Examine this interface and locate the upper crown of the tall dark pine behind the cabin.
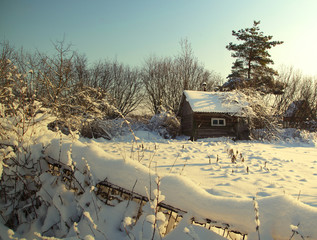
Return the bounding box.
[226,21,283,80]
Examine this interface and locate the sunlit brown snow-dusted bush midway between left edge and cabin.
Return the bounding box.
[48,86,119,138]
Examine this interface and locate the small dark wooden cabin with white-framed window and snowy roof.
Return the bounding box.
[178,90,250,140]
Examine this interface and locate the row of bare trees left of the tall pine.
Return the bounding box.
[0,37,222,118]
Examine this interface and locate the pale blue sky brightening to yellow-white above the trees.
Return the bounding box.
[0,0,317,77]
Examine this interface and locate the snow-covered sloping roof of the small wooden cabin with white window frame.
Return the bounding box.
[184,90,248,115]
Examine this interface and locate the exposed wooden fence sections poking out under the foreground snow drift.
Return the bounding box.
[45,157,247,240]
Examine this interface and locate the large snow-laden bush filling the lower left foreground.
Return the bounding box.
[0,62,104,239]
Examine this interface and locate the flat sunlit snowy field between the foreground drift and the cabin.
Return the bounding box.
[91,131,317,208]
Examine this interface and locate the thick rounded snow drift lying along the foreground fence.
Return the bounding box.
[47,132,317,239]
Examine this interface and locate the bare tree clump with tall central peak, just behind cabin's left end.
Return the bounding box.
[142,40,222,113]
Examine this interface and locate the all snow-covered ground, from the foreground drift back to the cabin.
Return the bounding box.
[0,115,317,240]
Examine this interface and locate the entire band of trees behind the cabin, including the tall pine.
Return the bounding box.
[0,21,317,132]
